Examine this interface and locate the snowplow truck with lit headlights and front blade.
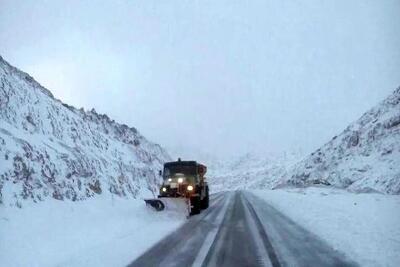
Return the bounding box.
[145,159,209,215]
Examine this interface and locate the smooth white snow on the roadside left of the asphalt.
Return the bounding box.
[0,194,185,267]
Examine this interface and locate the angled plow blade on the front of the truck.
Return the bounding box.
[144,197,190,215]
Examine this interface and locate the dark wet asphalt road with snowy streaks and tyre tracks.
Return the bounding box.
[129,191,357,267]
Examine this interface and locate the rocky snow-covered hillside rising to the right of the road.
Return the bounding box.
[281,88,400,194]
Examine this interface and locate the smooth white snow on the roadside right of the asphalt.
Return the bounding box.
[252,187,400,267]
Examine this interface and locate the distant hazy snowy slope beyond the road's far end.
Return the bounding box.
[207,152,300,192]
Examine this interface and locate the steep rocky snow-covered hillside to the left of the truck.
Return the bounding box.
[0,57,170,206]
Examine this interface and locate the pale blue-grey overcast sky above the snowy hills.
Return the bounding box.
[0,0,400,158]
